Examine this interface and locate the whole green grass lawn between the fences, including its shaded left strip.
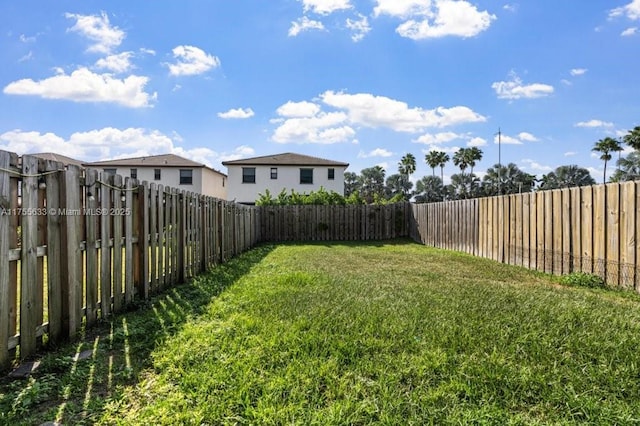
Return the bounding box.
[0,241,640,425]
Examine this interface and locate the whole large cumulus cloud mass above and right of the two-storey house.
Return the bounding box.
[271,90,486,143]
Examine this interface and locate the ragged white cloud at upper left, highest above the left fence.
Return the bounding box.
[65,12,126,54]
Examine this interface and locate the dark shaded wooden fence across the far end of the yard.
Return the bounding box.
[260,203,411,242]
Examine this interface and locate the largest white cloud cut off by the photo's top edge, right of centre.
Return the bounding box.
[374,0,496,40]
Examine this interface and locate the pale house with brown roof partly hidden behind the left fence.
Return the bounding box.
[83,154,227,200]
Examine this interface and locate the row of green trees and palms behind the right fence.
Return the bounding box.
[345,126,640,203]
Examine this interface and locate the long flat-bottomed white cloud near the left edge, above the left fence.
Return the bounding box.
[3,68,156,108]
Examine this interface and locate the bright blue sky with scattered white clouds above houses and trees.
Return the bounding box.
[0,0,640,185]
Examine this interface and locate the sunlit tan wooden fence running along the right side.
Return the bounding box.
[411,182,640,291]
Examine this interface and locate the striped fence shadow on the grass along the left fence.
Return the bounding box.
[0,245,273,424]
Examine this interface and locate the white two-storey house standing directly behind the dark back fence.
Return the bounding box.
[222,153,349,204]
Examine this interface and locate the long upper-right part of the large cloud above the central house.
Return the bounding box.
[320,90,486,133]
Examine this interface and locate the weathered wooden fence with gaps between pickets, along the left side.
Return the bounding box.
[0,151,260,368]
